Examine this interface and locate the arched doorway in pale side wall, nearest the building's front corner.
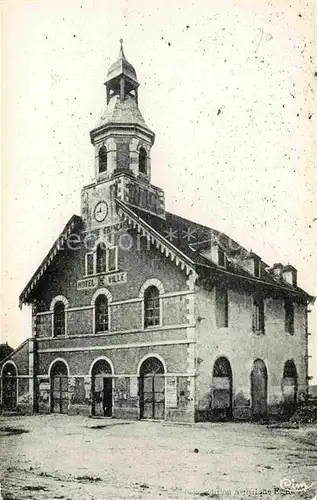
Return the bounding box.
[211,357,232,420]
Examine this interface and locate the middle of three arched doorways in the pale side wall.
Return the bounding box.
[251,359,267,418]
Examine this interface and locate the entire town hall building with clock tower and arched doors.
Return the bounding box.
[0,45,313,421]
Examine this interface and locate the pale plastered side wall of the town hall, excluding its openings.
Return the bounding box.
[196,287,308,420]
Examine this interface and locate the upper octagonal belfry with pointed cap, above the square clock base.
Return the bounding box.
[90,39,155,182]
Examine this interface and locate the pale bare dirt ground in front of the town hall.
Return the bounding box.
[0,415,317,500]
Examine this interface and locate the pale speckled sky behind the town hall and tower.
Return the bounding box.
[1,0,317,383]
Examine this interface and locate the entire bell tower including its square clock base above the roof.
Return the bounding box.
[82,39,165,229]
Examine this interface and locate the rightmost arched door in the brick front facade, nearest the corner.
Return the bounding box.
[140,357,165,420]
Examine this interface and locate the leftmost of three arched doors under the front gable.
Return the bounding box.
[50,361,68,413]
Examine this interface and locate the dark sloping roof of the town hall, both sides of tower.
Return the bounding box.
[19,200,314,306]
